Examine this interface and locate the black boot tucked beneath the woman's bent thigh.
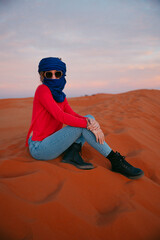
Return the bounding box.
[62,143,94,169]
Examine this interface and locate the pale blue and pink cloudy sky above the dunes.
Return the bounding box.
[0,0,160,98]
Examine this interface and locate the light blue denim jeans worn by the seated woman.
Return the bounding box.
[28,114,112,160]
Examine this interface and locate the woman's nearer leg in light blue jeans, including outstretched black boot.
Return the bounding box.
[29,115,144,179]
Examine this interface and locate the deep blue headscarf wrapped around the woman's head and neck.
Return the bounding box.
[38,57,66,102]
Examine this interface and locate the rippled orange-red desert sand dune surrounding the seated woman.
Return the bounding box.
[0,90,160,240]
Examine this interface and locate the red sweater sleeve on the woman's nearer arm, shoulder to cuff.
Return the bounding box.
[37,85,87,128]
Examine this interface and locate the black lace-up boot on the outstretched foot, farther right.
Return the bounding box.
[106,151,144,179]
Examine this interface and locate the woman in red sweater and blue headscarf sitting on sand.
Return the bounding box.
[26,57,144,179]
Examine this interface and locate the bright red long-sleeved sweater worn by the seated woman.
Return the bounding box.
[26,84,87,146]
